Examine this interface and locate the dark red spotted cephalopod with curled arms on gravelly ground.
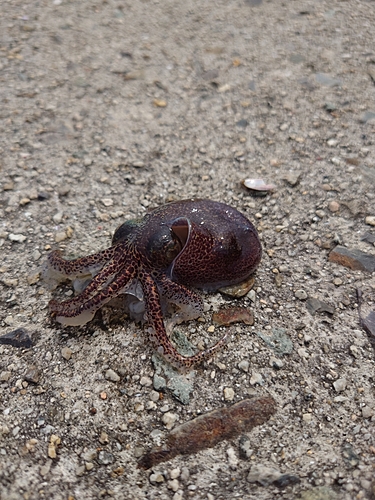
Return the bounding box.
[45,199,261,368]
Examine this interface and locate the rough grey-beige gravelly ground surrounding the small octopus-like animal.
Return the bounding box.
[0,0,375,500]
